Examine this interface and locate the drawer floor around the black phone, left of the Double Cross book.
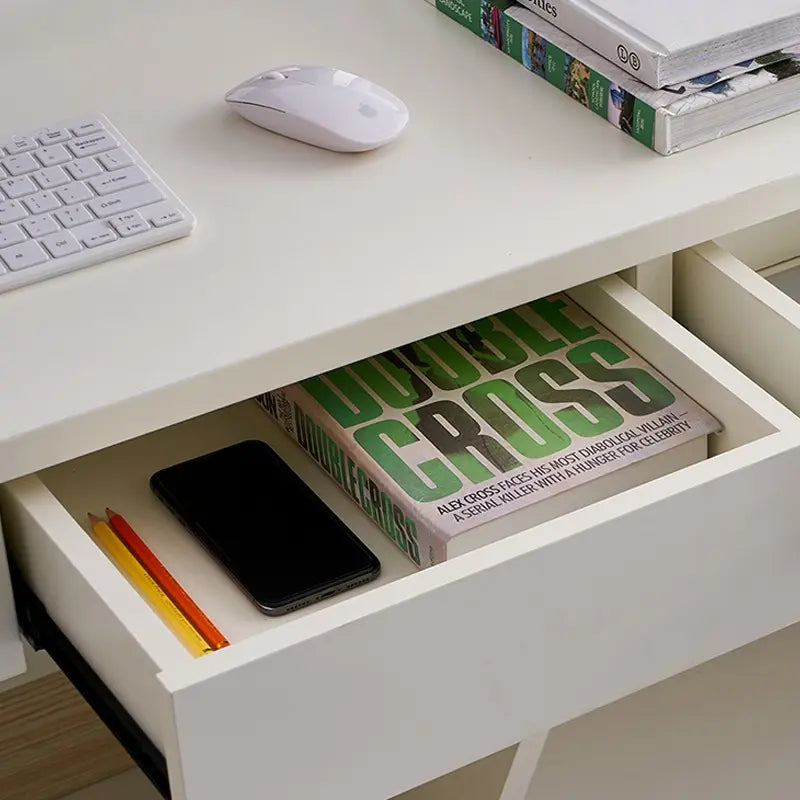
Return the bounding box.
[39,400,416,657]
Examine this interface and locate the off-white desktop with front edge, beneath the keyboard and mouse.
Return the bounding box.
[0,0,800,480]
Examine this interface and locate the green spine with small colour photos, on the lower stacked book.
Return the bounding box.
[428,0,661,152]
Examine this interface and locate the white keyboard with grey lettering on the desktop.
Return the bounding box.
[0,114,195,292]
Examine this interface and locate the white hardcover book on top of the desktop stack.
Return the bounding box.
[519,0,800,88]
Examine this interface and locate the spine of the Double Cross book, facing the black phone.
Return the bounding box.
[255,392,447,567]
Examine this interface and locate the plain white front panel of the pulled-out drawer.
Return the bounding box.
[162,434,800,800]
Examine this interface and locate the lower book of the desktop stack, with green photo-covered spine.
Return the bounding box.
[428,0,800,155]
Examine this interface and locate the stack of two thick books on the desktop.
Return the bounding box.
[428,0,800,155]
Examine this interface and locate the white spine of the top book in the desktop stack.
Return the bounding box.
[517,0,663,88]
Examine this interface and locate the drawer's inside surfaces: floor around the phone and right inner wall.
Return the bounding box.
[29,278,776,643]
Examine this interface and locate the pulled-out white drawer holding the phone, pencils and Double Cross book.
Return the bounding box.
[0,277,800,800]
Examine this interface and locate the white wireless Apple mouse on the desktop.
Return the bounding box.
[225,66,408,153]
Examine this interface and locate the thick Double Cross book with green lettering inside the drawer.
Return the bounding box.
[256,294,720,567]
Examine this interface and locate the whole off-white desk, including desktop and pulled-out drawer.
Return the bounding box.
[0,0,800,800]
